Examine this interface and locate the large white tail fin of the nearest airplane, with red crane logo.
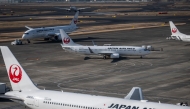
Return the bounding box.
[0,46,39,91]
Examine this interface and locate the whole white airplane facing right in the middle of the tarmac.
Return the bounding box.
[60,30,150,59]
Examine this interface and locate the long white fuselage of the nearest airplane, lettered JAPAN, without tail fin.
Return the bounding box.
[6,90,190,109]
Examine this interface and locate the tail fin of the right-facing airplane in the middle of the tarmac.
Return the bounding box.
[60,29,79,46]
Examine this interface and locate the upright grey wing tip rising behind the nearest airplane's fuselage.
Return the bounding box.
[124,87,143,100]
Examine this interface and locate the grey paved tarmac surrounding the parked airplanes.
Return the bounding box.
[0,2,190,109]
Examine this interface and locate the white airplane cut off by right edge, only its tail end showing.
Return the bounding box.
[166,21,190,42]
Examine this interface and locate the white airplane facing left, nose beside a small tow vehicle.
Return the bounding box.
[22,11,79,43]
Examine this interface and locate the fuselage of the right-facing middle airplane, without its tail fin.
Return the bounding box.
[62,45,150,56]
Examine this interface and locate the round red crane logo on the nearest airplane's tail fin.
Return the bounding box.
[9,64,22,83]
